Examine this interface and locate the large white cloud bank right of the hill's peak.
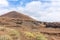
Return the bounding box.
[17,0,60,22]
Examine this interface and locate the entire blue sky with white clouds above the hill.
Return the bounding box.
[0,0,60,22]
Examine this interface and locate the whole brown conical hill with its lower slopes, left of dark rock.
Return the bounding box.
[0,11,45,29]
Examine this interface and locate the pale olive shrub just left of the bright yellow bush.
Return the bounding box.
[6,28,20,40]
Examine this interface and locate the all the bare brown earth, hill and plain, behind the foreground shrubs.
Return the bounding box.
[0,11,60,40]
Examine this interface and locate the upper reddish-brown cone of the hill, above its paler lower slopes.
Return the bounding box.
[1,11,33,20]
